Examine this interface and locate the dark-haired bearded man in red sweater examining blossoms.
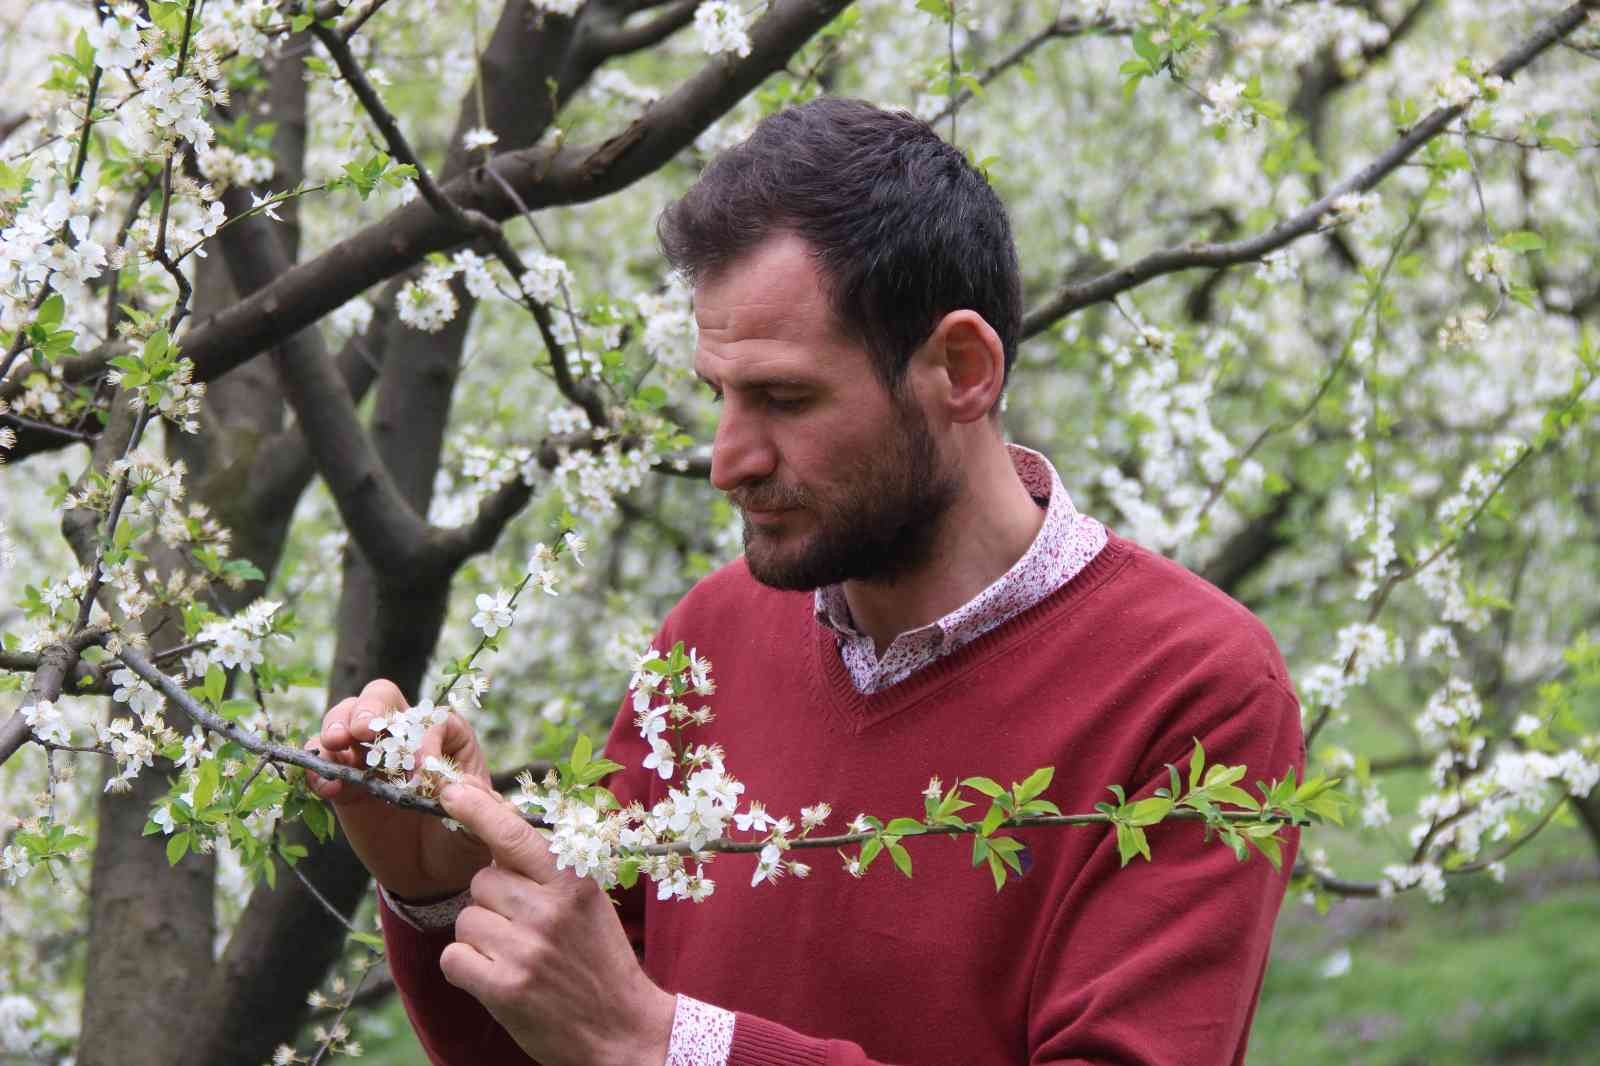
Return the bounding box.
[308,99,1302,1066]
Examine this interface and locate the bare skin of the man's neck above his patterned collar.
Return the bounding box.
[845,445,1045,655]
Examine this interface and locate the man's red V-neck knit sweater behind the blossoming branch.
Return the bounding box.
[384,536,1304,1066]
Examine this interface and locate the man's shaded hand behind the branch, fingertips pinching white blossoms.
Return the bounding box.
[306,679,491,900]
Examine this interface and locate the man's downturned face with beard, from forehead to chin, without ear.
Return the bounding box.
[694,235,960,589]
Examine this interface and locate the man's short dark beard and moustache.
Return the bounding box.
[731,397,960,591]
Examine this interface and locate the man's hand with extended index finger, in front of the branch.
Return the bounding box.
[438,784,677,1066]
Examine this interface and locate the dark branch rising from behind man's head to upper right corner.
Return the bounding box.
[1022,0,1600,338]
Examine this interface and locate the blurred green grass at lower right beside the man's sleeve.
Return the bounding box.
[1250,861,1600,1066]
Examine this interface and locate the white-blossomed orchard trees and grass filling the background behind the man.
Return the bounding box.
[0,0,1600,1066]
